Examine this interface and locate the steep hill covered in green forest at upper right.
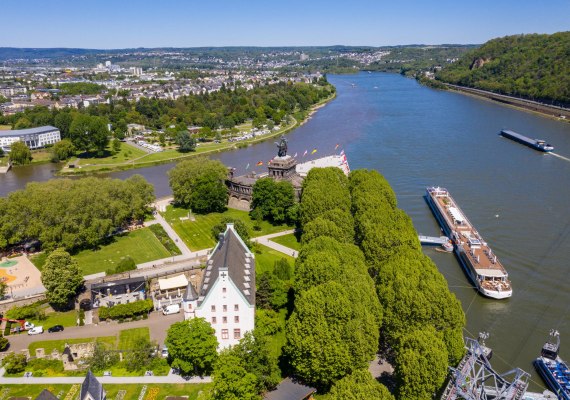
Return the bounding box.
[436,32,570,106]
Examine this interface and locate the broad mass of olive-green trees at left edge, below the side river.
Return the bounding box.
[0,175,154,251]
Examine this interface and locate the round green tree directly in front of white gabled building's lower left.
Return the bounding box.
[165,318,218,376]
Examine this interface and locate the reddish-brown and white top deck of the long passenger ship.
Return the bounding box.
[429,192,511,290]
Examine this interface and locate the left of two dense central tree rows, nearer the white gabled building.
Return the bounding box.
[285,168,382,391]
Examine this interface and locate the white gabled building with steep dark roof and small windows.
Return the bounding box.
[183,224,255,350]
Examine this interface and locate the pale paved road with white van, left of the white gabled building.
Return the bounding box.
[8,312,184,356]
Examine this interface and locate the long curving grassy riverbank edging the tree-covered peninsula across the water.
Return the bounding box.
[56,91,336,176]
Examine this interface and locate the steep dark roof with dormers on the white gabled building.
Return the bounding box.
[198,224,255,305]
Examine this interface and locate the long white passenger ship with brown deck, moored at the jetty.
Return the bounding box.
[425,187,513,299]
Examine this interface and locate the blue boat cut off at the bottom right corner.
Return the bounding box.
[534,330,570,400]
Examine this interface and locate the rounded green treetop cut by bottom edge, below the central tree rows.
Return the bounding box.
[326,369,394,400]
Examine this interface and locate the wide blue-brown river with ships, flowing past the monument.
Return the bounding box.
[0,73,570,389]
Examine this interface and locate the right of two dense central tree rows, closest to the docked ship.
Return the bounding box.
[350,170,465,399]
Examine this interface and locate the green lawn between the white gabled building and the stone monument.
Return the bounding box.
[163,206,293,251]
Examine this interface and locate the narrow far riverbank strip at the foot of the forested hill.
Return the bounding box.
[437,81,570,122]
